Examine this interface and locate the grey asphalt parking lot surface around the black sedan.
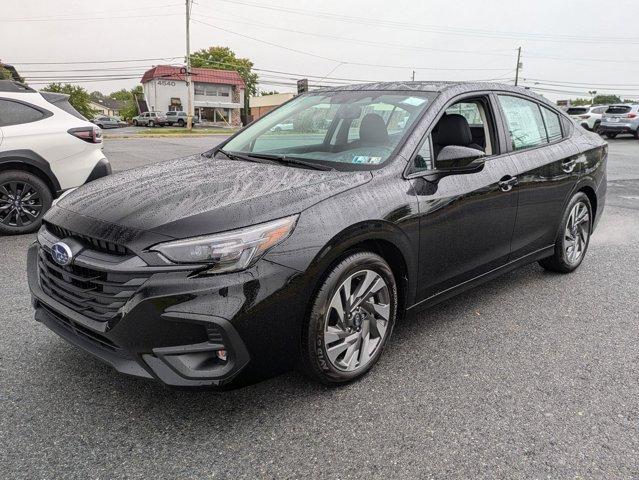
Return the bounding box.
[0,133,639,479]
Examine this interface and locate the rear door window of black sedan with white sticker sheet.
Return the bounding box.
[499,95,548,150]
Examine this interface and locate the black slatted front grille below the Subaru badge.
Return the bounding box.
[38,248,146,322]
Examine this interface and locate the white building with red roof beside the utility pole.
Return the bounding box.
[141,65,245,127]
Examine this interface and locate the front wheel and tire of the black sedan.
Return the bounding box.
[301,252,398,385]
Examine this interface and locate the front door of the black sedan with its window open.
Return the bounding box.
[409,95,518,301]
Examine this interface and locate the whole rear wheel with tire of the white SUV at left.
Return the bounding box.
[0,170,53,235]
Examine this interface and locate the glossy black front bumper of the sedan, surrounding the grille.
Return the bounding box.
[27,232,304,387]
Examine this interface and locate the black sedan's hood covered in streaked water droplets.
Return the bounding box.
[51,155,372,238]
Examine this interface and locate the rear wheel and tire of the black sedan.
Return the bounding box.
[539,192,593,273]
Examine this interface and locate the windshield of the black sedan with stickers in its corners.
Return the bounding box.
[223,91,436,170]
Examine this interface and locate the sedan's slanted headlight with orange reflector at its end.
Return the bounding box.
[151,215,298,273]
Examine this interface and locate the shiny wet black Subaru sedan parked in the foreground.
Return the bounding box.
[28,82,607,387]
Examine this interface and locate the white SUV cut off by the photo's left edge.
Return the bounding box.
[0,80,111,234]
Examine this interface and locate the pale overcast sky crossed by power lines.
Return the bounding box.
[0,0,639,99]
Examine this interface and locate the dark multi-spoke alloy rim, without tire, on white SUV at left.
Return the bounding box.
[0,181,42,227]
